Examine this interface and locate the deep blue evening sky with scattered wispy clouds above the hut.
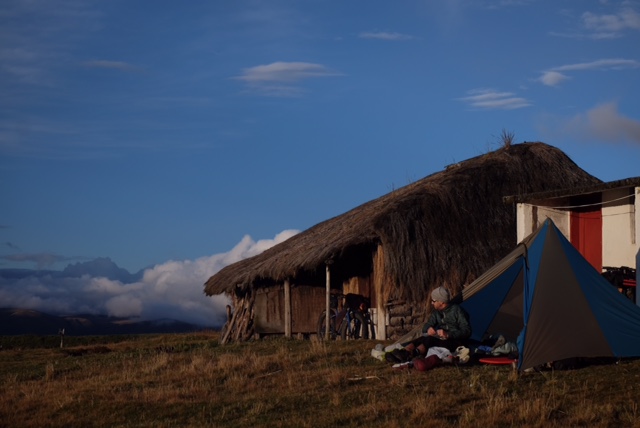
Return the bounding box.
[0,0,640,326]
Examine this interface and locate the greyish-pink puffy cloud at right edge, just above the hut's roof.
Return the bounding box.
[546,102,640,144]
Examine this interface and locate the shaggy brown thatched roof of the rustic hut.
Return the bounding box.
[205,143,601,301]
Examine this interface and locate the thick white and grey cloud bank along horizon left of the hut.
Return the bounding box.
[0,230,298,328]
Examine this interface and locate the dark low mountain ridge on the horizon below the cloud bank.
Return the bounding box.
[0,308,207,336]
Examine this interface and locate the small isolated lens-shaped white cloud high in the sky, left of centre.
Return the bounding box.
[234,61,341,97]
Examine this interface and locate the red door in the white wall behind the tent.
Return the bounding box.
[571,210,602,272]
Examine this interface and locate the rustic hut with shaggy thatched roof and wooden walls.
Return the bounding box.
[205,143,601,342]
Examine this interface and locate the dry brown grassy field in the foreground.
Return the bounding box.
[0,332,640,427]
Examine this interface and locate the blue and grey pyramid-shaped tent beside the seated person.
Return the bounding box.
[462,219,640,370]
